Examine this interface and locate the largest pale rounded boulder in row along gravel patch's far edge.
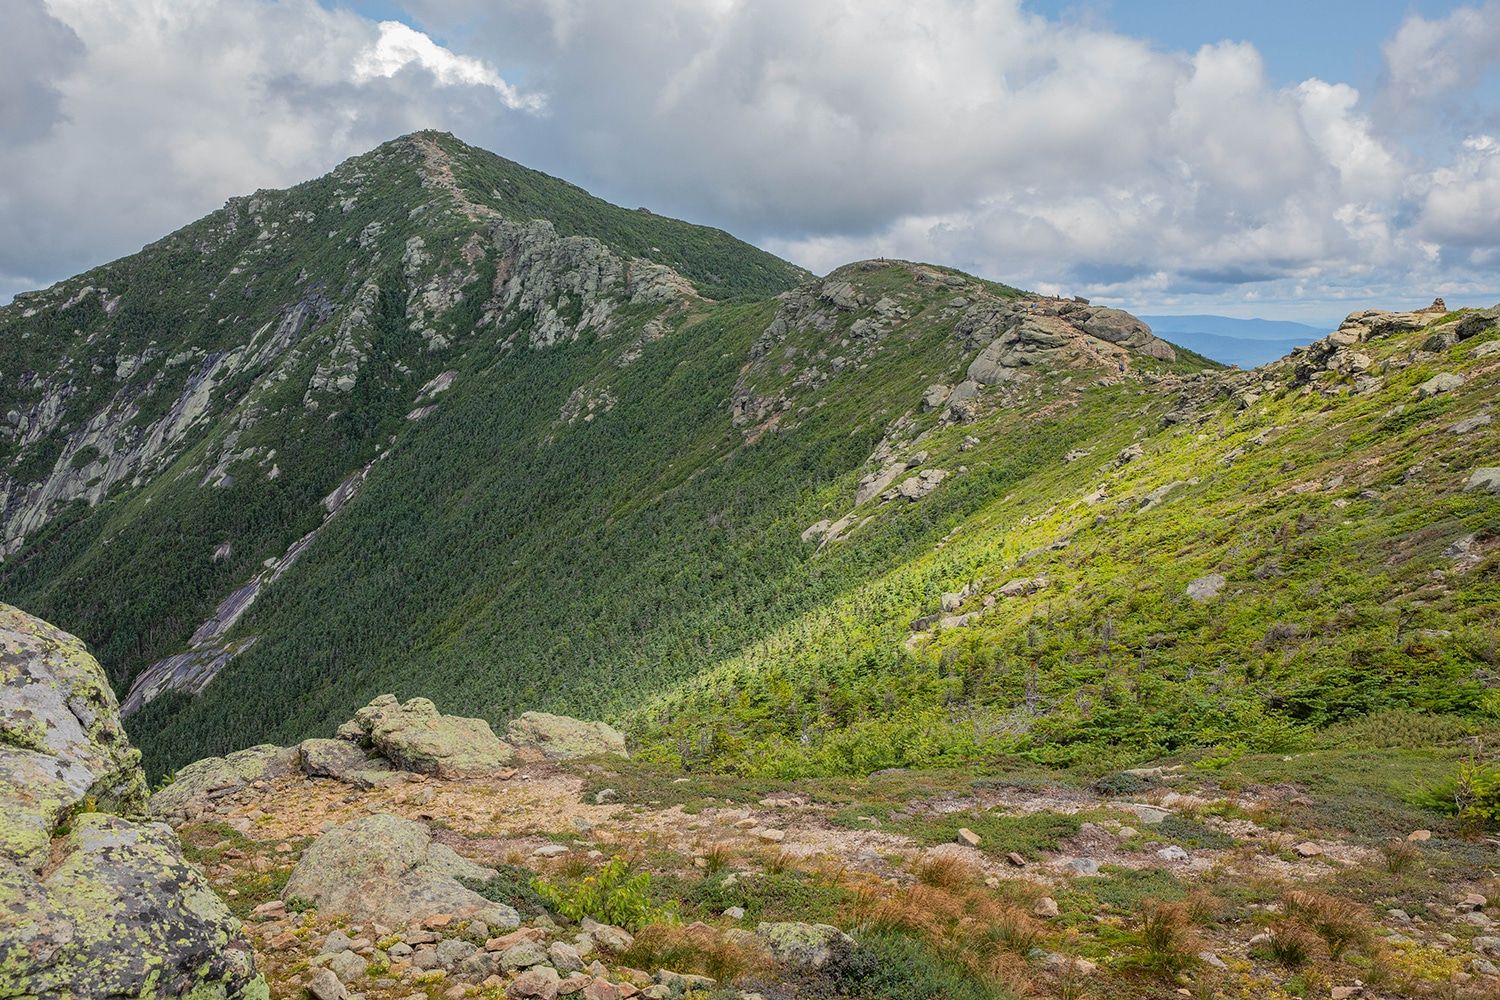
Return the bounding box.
[339,694,515,778]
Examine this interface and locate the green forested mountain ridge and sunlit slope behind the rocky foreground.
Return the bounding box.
[0,133,1497,774]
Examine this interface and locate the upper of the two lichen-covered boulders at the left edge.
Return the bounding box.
[0,604,146,859]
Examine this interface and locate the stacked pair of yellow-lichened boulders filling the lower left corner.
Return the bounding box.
[0,604,270,1000]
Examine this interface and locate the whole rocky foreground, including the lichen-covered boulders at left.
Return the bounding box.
[0,606,1500,1000]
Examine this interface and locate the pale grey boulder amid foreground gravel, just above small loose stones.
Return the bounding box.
[282,813,521,931]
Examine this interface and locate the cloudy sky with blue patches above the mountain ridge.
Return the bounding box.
[0,0,1500,324]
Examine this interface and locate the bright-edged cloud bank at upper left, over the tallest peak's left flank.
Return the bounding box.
[0,0,537,301]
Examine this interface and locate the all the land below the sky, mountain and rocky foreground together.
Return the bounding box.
[0,132,1500,1000]
